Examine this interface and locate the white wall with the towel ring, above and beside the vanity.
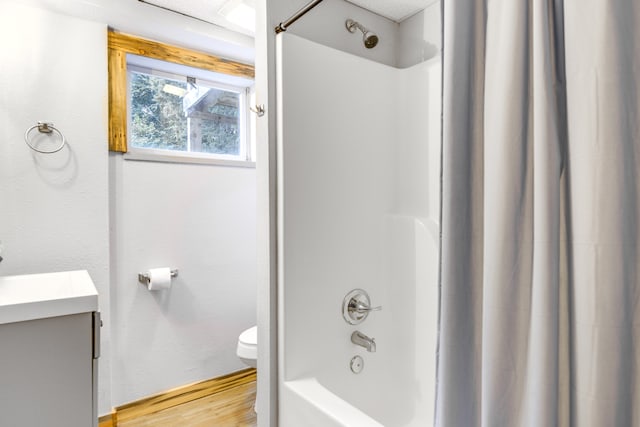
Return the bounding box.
[0,2,111,413]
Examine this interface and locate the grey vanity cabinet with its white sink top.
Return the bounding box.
[0,271,101,427]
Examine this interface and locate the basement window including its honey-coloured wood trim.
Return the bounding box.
[109,32,253,164]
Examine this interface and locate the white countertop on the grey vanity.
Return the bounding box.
[0,270,98,324]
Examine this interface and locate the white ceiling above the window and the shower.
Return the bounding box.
[139,0,438,35]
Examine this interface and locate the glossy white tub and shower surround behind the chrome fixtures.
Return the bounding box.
[278,34,440,426]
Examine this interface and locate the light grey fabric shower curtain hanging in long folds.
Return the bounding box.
[435,0,640,427]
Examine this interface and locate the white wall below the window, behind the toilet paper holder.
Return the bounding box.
[111,153,256,406]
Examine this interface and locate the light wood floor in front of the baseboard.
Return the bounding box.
[111,372,257,427]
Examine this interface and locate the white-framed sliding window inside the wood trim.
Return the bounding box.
[127,55,252,161]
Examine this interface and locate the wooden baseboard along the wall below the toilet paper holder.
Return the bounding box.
[112,368,256,427]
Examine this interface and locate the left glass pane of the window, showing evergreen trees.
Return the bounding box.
[129,72,187,151]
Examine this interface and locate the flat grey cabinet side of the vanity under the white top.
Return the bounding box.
[0,313,94,427]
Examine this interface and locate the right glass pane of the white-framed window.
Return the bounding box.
[184,86,240,155]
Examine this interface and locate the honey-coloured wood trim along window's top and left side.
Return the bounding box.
[107,30,255,153]
